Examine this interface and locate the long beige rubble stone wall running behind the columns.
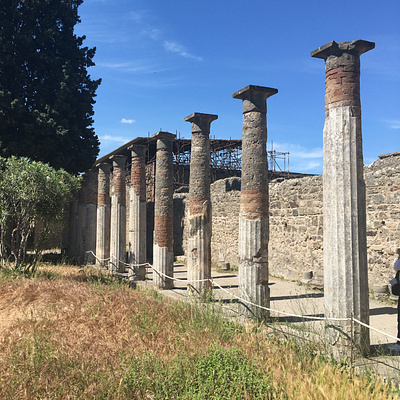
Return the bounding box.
[174,153,400,287]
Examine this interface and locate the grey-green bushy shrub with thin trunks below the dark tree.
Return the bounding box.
[0,157,81,270]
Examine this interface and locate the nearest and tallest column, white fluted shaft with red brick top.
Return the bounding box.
[311,40,375,353]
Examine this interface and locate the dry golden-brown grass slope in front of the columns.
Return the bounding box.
[0,266,397,399]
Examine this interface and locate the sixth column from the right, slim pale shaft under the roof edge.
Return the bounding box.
[110,155,126,272]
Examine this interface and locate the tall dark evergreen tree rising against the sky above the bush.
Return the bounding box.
[0,0,100,173]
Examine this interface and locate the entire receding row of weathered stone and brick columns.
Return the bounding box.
[69,40,374,353]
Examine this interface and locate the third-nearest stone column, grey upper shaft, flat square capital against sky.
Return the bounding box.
[185,113,218,295]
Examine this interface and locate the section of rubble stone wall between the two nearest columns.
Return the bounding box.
[268,176,323,280]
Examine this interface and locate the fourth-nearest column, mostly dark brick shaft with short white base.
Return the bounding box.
[153,132,175,289]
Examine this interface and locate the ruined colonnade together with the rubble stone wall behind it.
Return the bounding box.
[62,40,400,352]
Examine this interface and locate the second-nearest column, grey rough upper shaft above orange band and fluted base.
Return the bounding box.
[233,85,278,319]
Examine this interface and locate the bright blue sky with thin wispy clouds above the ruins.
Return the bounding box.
[76,0,400,173]
